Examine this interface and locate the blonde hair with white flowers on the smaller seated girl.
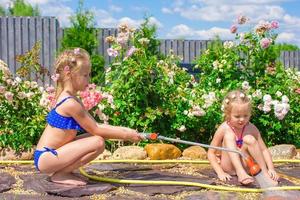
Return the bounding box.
[222,90,251,121]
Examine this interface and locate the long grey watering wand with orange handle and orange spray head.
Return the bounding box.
[140,133,261,176]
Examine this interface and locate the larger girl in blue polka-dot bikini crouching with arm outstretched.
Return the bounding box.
[34,48,142,185]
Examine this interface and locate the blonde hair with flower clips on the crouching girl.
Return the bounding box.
[54,48,90,100]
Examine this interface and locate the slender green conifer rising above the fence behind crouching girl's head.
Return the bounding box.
[60,0,104,84]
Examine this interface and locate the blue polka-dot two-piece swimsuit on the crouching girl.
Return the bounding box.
[33,96,84,170]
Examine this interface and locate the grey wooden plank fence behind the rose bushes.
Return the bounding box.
[0,17,300,81]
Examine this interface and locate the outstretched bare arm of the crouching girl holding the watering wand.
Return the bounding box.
[65,99,141,142]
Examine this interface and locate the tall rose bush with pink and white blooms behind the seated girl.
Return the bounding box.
[196,17,300,146]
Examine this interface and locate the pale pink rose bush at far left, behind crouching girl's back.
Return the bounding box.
[0,61,46,151]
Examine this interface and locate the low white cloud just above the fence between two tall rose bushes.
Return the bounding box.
[167,24,233,40]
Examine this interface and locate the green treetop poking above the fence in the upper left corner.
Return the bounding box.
[8,0,40,16]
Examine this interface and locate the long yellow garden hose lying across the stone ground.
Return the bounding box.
[0,159,300,193]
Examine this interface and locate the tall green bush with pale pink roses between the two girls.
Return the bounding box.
[93,20,210,148]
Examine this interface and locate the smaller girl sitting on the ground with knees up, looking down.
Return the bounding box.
[207,90,278,186]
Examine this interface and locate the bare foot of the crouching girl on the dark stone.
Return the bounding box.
[50,172,87,186]
